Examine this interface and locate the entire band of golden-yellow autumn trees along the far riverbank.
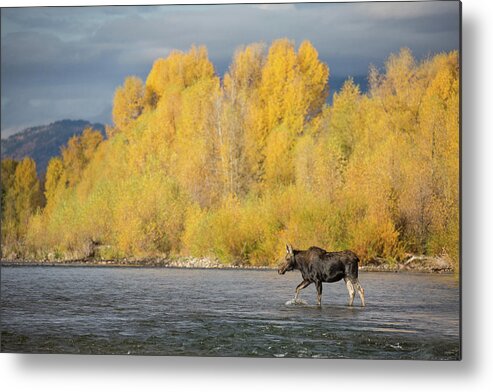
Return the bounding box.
[1,39,459,266]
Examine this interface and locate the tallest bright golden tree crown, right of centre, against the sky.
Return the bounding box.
[247,39,328,189]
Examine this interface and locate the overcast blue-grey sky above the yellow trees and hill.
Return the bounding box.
[1,1,459,137]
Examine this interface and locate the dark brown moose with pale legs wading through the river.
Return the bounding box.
[278,244,365,306]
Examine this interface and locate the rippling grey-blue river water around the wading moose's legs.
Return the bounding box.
[0,267,460,360]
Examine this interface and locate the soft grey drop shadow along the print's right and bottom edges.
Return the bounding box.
[13,4,474,382]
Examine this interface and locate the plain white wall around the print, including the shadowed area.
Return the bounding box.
[0,0,493,392]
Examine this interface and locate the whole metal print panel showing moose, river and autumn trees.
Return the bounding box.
[0,1,461,360]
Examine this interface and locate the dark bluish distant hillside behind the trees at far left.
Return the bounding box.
[2,120,104,174]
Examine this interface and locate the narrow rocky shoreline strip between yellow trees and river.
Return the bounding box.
[1,255,454,273]
